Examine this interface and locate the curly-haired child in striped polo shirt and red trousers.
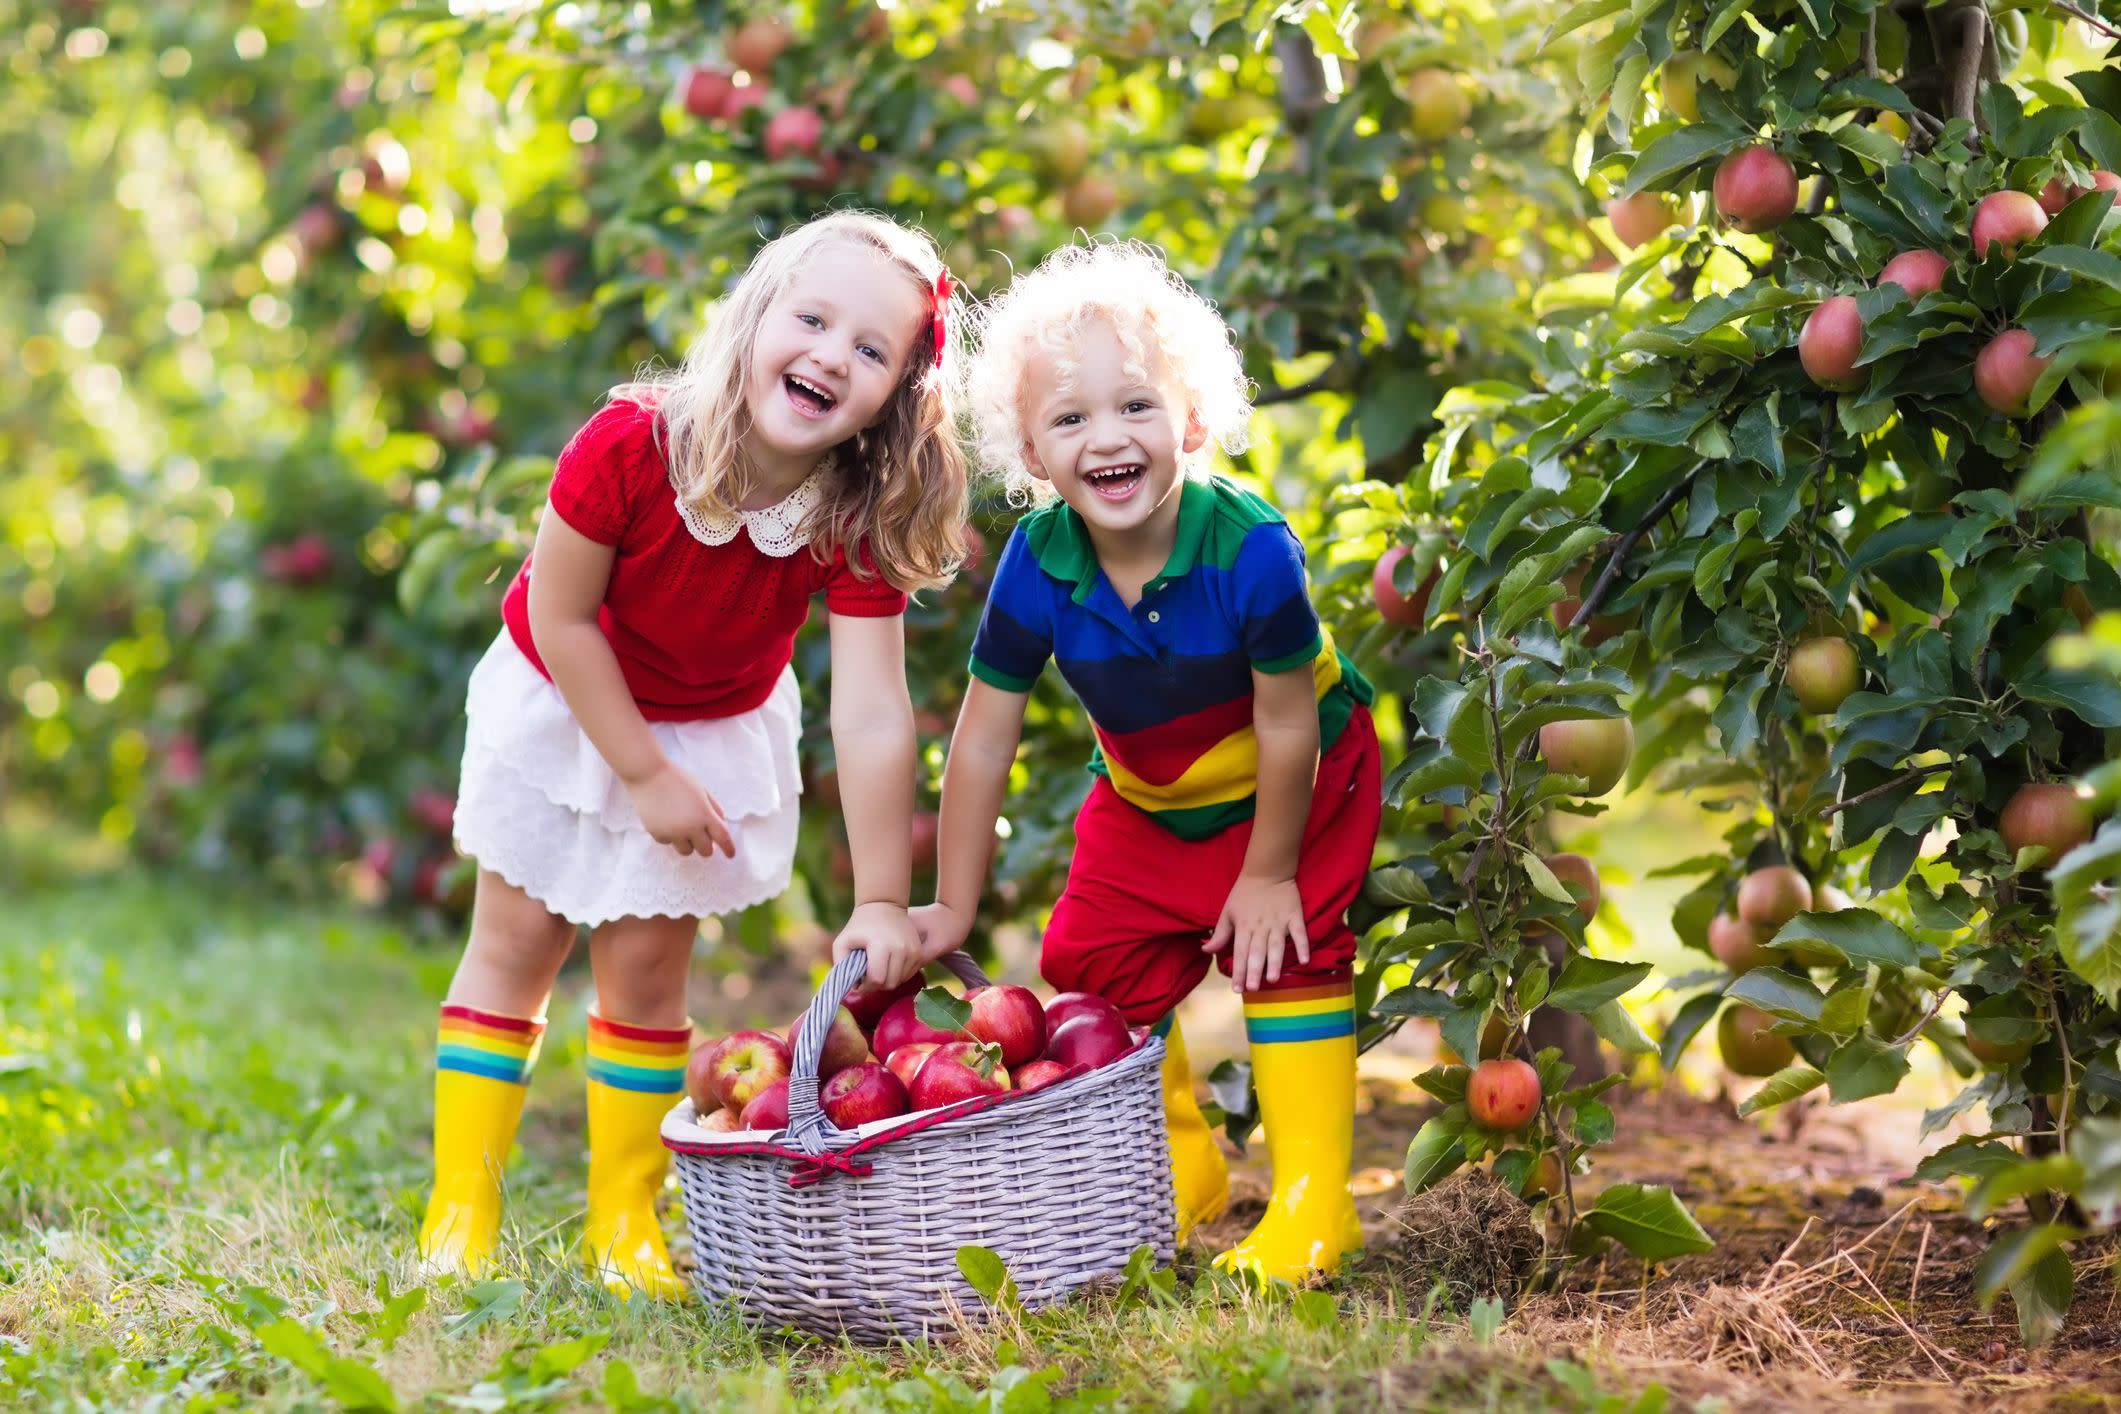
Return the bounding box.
[914,244,1381,1280]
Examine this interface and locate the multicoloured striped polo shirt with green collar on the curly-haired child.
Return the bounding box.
[971,477,1372,839]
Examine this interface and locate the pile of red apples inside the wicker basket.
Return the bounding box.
[685,977,1137,1134]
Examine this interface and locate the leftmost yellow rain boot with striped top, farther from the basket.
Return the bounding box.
[420,1007,545,1276]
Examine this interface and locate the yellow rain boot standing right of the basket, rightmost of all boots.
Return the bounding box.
[1215,984,1362,1283]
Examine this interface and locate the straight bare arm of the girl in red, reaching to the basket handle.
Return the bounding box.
[831,615,921,988]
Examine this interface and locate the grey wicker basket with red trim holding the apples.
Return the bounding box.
[662,952,1175,1342]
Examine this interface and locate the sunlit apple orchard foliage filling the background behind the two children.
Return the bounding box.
[12,0,2121,1408]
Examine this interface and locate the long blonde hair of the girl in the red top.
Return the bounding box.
[611,212,967,591]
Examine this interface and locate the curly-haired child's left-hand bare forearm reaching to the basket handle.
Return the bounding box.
[914,678,1031,960]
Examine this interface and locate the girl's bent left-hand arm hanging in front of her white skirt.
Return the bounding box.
[530,511,736,856]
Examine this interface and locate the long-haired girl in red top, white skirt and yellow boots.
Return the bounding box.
[420,212,965,1297]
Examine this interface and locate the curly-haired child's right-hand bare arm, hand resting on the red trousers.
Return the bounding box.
[1205,664,1319,992]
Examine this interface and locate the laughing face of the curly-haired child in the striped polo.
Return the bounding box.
[1024,320,1207,538]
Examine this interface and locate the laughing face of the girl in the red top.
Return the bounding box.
[744,242,929,460]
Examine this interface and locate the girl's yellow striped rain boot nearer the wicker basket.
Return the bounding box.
[581,1015,691,1302]
